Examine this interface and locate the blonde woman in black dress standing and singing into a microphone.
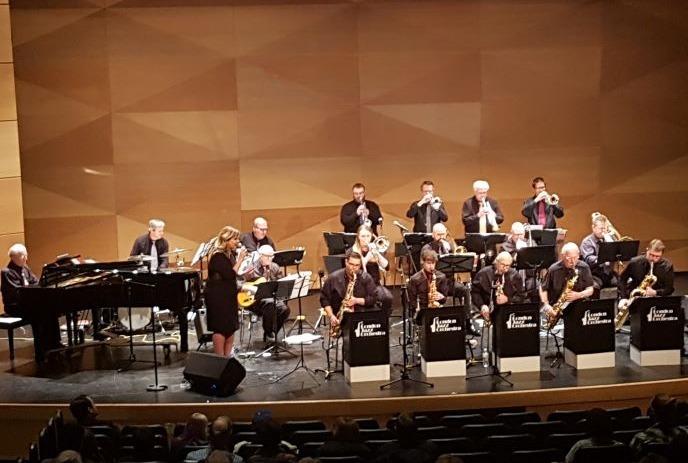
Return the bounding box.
[205,226,246,357]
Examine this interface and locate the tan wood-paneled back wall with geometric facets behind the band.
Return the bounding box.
[9,0,688,278]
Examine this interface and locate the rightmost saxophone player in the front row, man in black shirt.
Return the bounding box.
[619,239,674,304]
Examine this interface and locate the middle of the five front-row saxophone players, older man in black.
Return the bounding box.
[471,251,526,320]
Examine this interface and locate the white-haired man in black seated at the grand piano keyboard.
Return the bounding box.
[0,243,62,360]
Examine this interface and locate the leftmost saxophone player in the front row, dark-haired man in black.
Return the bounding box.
[320,250,375,332]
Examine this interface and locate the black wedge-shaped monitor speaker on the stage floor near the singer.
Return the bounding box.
[183,352,246,397]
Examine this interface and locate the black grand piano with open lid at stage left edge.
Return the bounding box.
[18,256,201,359]
